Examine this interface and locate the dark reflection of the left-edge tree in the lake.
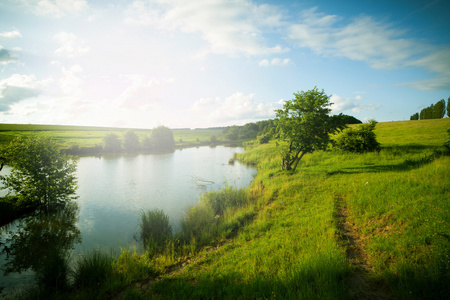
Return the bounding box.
[0,201,81,289]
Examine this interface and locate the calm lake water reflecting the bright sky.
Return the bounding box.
[0,146,256,298]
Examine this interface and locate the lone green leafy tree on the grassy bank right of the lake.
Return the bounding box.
[276,87,345,171]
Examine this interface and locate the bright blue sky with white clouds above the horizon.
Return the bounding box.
[0,0,450,129]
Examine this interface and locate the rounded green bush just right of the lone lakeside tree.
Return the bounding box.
[333,120,380,153]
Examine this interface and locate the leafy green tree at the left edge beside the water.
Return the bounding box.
[0,135,77,210]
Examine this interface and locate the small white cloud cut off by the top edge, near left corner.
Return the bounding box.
[19,0,88,18]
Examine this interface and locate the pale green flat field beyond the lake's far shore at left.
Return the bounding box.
[0,124,223,149]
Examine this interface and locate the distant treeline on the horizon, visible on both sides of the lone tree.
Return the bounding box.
[223,114,362,143]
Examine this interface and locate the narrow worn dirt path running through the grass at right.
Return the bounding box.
[335,194,392,299]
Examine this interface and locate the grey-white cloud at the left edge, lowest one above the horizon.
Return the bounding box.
[0,74,51,112]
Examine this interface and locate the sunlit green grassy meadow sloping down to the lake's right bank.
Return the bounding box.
[3,119,450,299]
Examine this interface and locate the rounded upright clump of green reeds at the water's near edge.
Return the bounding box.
[139,209,172,252]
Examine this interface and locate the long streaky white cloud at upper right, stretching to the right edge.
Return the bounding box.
[287,8,450,90]
